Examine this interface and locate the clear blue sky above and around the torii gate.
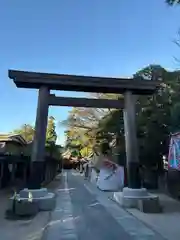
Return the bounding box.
[0,0,180,143]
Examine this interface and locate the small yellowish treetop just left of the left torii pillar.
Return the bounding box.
[13,124,35,142]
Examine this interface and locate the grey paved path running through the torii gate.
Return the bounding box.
[43,171,163,240]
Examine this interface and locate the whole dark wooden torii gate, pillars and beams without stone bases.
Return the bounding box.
[9,70,160,189]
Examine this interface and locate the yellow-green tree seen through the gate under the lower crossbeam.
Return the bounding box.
[60,94,120,157]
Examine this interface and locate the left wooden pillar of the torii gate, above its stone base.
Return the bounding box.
[29,86,50,189]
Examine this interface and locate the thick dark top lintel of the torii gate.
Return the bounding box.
[9,70,160,95]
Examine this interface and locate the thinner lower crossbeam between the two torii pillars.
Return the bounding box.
[49,94,124,109]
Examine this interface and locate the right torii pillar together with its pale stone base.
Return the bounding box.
[114,91,156,208]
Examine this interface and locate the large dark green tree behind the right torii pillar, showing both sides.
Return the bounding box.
[92,65,180,171]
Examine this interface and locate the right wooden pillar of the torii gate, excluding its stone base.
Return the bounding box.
[124,91,141,189]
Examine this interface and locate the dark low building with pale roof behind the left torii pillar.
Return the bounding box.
[0,134,62,189]
